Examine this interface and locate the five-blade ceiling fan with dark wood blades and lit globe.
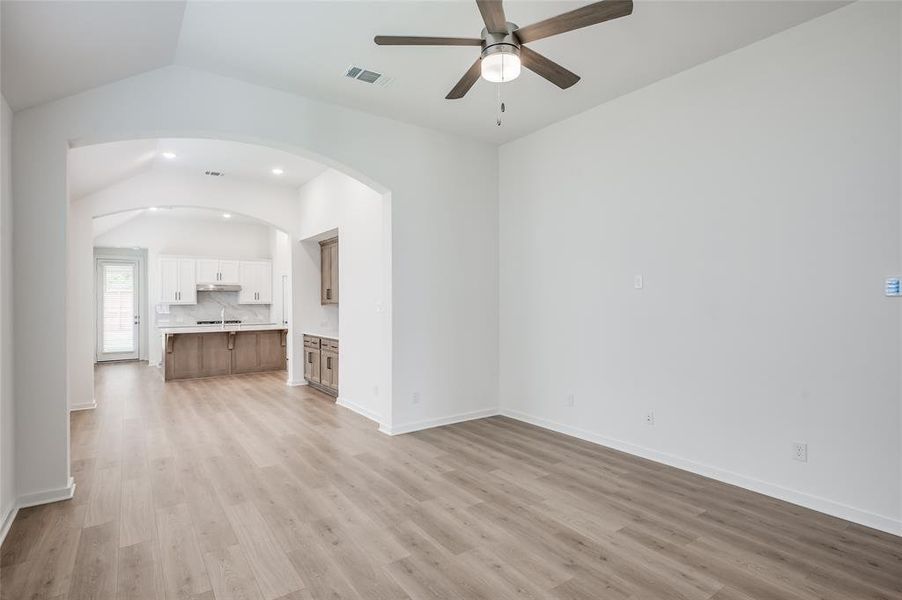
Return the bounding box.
[373,0,633,100]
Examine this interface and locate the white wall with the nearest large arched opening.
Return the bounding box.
[13,67,498,504]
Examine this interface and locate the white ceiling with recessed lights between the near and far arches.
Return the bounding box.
[69,138,327,198]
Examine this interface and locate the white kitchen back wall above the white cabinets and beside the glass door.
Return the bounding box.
[94,212,276,365]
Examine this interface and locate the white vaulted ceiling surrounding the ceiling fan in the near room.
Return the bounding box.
[2,0,846,143]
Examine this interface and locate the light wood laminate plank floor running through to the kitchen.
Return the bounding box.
[0,363,902,600]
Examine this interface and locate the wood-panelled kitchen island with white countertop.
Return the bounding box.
[160,323,288,381]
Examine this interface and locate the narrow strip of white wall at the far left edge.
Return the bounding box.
[0,96,16,542]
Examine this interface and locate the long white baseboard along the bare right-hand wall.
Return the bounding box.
[500,408,902,535]
